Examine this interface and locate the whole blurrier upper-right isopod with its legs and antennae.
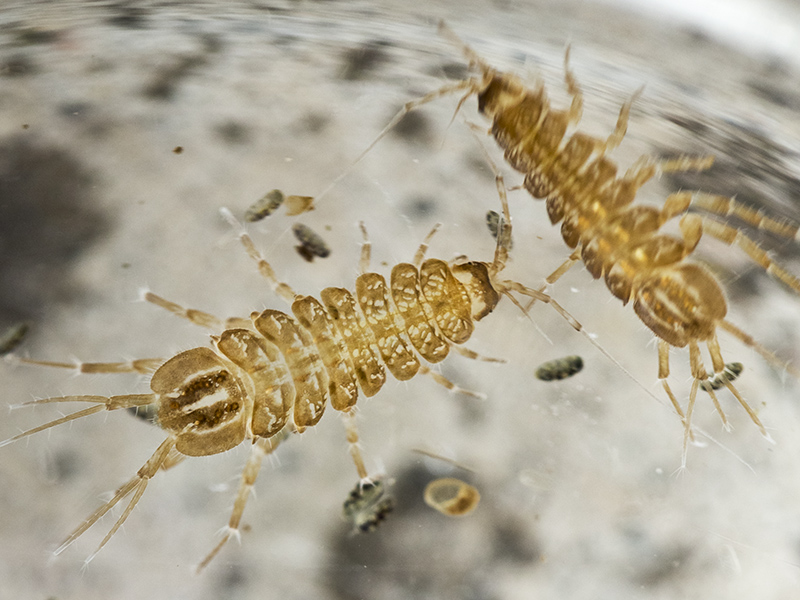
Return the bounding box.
[359,23,800,465]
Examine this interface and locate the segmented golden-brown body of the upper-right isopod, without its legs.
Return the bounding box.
[478,73,726,347]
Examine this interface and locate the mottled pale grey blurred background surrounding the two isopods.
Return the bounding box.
[0,0,800,600]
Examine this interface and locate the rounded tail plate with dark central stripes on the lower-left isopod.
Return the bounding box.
[150,348,246,456]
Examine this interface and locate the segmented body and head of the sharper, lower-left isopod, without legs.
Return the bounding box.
[151,259,499,455]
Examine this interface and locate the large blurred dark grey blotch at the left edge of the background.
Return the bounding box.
[0,134,108,321]
